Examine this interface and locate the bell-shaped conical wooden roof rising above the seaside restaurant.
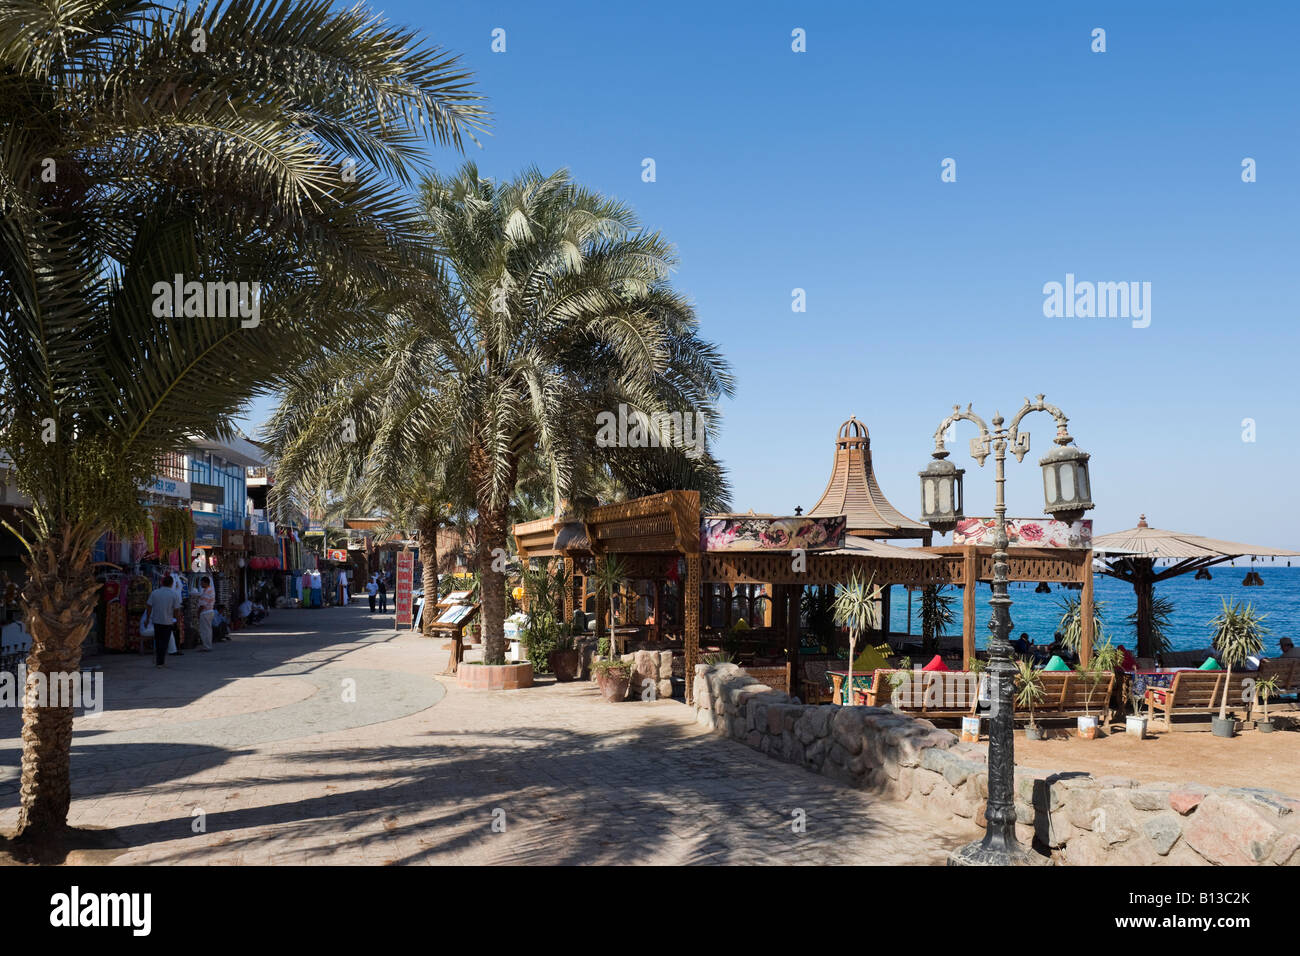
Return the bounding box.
[809,418,931,538]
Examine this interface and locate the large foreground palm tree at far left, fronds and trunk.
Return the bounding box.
[0,0,484,843]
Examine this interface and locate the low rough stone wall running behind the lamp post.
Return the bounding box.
[694,665,1300,866]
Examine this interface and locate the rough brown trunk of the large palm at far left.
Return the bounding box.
[16,525,99,843]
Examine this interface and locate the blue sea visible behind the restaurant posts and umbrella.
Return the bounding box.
[889,558,1300,657]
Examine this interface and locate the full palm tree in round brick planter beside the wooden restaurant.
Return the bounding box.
[265,164,732,663]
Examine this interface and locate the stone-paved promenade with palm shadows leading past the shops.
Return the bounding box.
[0,605,970,865]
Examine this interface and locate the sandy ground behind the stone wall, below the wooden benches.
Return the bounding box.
[982,713,1300,796]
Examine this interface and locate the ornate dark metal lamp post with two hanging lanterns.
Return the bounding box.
[920,395,1092,866]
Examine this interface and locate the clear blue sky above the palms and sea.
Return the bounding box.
[244,0,1300,546]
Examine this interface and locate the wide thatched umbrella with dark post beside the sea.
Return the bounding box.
[1092,515,1300,657]
